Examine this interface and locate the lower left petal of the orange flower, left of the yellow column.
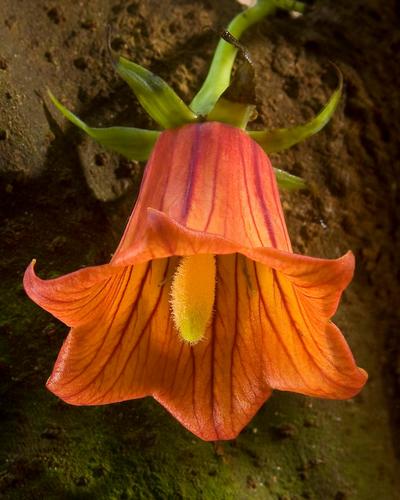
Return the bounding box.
[47,259,173,405]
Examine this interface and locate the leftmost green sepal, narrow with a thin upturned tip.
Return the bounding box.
[48,91,160,161]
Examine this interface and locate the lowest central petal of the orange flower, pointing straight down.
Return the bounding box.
[158,254,272,440]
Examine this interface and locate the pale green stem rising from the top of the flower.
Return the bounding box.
[190,0,305,116]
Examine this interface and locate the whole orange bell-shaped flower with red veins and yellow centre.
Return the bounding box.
[24,122,366,440]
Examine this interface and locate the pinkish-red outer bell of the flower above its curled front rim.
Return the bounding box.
[112,122,291,265]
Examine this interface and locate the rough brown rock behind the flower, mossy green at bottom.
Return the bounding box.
[0,0,400,500]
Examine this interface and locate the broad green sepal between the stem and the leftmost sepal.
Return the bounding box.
[116,57,198,128]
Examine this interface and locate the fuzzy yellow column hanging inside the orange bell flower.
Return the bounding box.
[170,254,216,344]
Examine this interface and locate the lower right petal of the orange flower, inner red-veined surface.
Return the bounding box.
[252,262,367,399]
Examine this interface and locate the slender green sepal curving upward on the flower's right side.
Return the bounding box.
[247,73,343,153]
